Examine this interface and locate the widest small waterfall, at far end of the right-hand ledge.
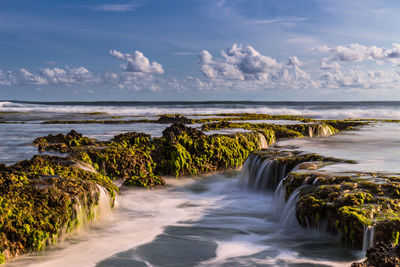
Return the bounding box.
[239,155,288,191]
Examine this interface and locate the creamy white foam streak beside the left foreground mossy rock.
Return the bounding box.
[6,180,219,267]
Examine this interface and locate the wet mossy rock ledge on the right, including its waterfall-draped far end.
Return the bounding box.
[249,147,400,266]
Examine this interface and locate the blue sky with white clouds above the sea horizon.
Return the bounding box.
[0,0,400,101]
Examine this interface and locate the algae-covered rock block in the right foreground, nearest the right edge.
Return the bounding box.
[283,171,400,249]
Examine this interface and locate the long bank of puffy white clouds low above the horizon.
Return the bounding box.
[0,43,400,92]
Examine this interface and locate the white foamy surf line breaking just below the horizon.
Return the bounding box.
[0,102,400,119]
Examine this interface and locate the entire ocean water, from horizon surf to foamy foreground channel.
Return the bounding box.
[0,101,400,266]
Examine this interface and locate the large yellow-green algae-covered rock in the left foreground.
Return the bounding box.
[0,156,117,260]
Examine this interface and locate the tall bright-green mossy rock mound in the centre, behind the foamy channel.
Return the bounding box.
[152,124,260,176]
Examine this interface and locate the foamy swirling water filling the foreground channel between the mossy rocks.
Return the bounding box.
[5,172,359,267]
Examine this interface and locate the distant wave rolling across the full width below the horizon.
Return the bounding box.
[0,101,400,119]
